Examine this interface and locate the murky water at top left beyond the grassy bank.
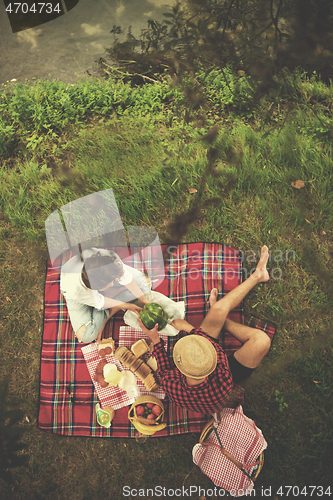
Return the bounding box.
[0,0,174,83]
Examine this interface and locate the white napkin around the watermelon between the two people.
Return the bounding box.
[124,291,185,336]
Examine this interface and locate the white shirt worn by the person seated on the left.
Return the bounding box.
[60,247,132,310]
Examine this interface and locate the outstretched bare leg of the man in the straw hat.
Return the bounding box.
[200,245,269,339]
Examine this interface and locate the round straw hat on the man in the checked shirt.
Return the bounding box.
[173,335,217,379]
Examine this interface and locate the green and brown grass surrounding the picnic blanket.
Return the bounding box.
[0,70,333,500]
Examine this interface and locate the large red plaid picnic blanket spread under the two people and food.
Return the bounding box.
[38,243,275,437]
